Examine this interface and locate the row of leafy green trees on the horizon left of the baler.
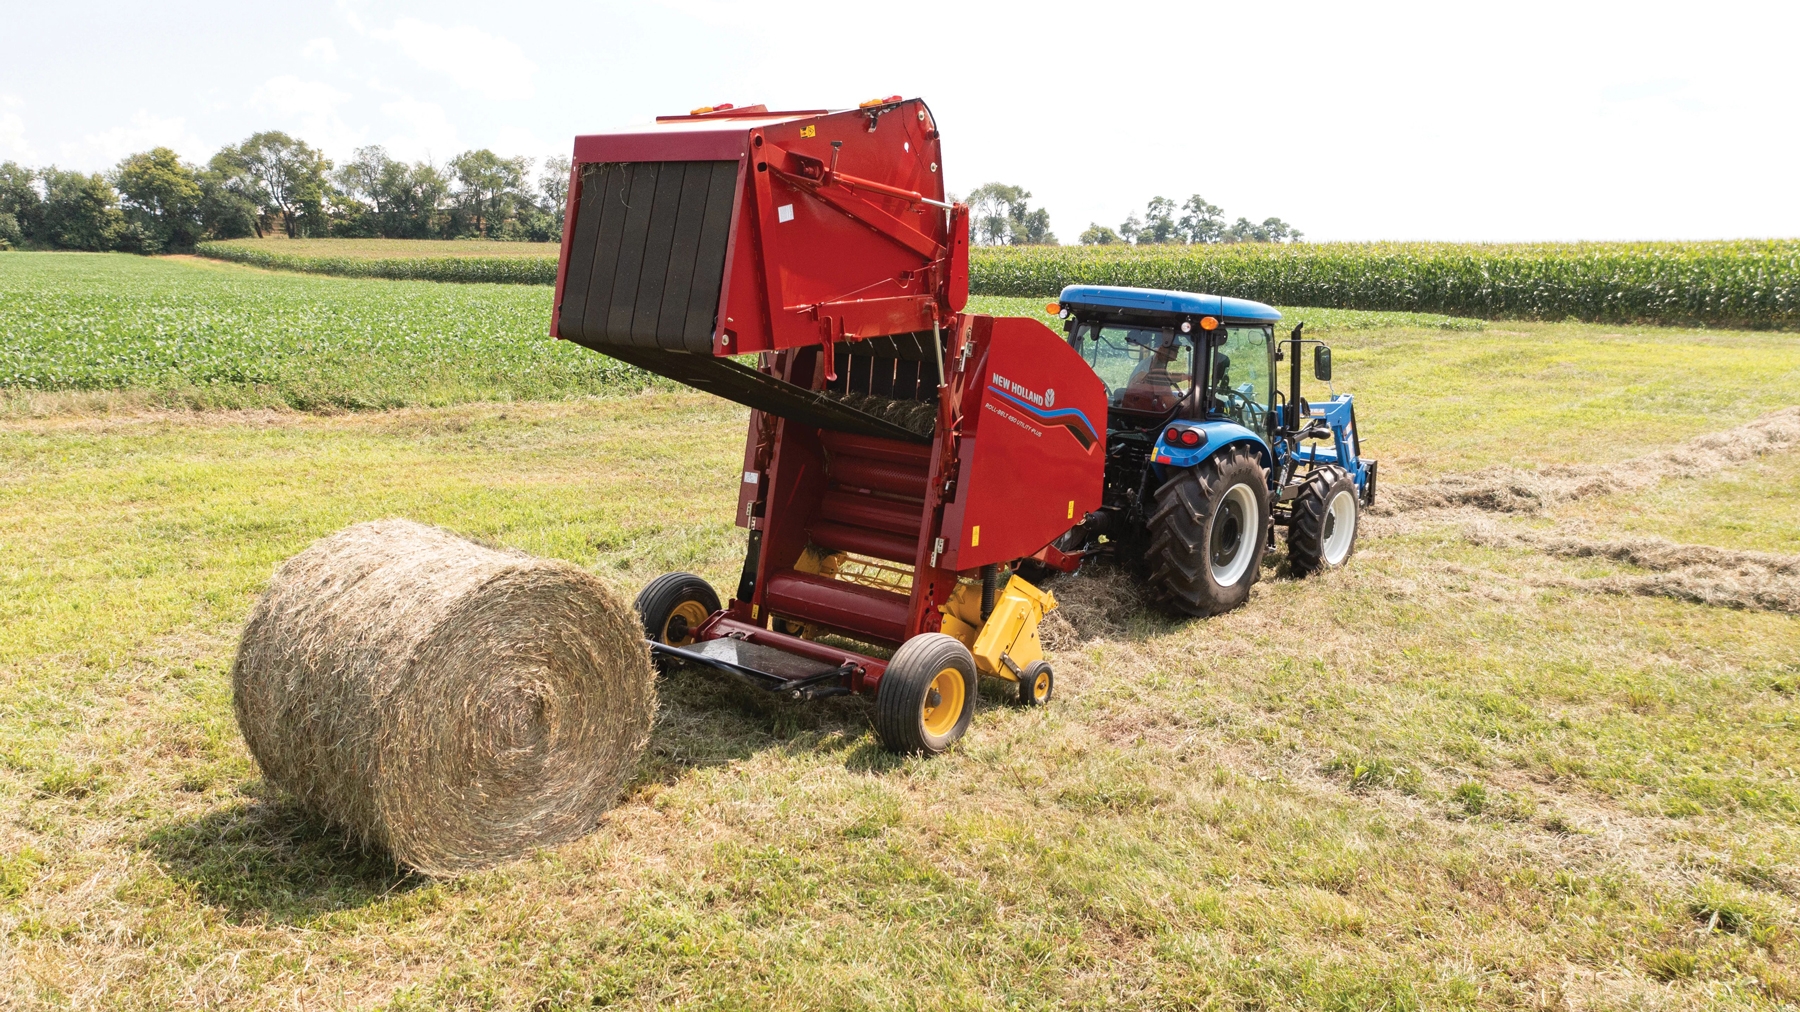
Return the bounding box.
[0,130,569,254]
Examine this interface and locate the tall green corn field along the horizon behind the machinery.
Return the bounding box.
[198,239,1800,330]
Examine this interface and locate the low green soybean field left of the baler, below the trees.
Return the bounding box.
[0,254,648,411]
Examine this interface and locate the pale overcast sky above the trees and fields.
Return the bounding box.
[0,0,1800,241]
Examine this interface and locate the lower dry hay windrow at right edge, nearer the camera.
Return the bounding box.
[1463,522,1800,614]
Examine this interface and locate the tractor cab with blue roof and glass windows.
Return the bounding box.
[1058,285,1282,445]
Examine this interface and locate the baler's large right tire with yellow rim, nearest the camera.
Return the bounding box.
[875,632,977,754]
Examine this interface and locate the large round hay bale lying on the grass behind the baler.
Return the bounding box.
[232,520,655,875]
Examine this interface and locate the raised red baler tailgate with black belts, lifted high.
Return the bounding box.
[553,99,967,358]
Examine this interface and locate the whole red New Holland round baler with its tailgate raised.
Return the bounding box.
[551,99,1105,751]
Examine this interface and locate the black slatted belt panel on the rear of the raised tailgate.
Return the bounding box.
[558,162,738,355]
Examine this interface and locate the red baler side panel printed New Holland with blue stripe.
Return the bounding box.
[943,317,1107,571]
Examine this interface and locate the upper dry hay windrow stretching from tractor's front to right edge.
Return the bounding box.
[1370,407,1800,517]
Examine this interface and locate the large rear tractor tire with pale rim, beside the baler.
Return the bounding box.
[1145,447,1269,618]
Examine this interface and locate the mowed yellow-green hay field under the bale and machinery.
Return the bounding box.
[0,254,1800,1008]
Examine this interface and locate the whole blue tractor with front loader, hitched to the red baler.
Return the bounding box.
[1053,285,1377,616]
